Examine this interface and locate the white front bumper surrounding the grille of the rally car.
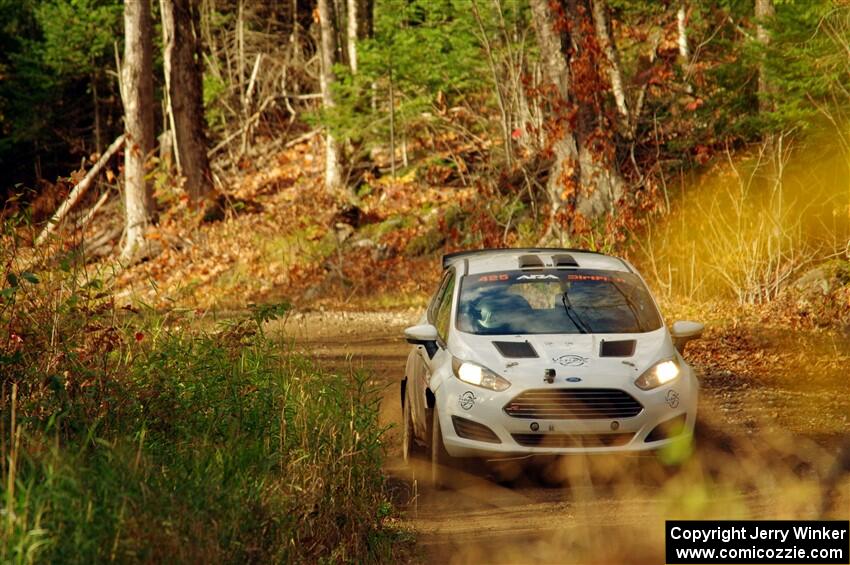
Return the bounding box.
[436,370,699,459]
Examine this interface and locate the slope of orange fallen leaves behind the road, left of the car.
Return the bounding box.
[107,135,458,311]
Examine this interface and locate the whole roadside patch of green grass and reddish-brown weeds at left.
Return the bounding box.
[0,228,404,563]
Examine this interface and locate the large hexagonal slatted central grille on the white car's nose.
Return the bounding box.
[504,388,643,420]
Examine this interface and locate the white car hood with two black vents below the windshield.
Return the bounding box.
[449,327,676,384]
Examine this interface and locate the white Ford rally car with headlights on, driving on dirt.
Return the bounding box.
[401,249,703,484]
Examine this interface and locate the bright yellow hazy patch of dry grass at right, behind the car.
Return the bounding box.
[635,131,850,305]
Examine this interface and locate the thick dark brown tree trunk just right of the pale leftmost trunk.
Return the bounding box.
[160,0,212,201]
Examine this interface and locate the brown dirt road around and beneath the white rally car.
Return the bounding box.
[285,312,850,563]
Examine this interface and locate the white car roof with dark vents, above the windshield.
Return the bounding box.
[443,247,632,274]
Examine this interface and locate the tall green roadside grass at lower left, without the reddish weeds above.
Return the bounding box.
[0,326,400,563]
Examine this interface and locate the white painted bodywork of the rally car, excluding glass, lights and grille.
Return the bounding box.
[405,250,699,458]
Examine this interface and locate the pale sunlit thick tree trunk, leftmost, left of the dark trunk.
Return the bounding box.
[121,0,154,261]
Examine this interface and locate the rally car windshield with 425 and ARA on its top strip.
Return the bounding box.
[457,269,661,335]
